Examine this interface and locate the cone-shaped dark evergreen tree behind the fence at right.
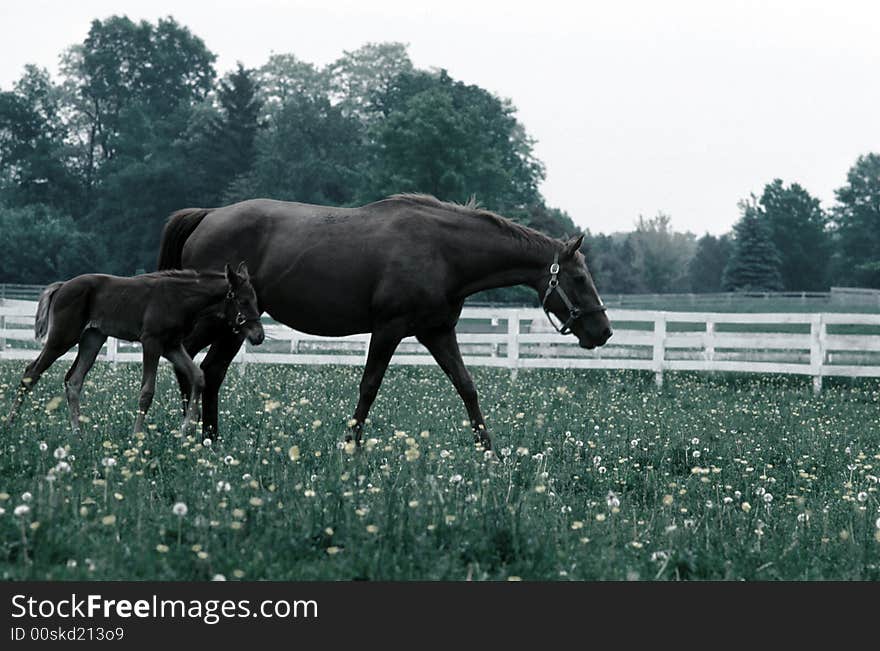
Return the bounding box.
[722,195,782,291]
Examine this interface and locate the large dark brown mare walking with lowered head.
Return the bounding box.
[158,195,611,448]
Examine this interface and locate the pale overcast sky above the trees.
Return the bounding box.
[0,0,880,233]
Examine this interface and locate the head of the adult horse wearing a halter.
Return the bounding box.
[540,235,612,349]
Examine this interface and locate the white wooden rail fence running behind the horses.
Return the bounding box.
[0,301,880,391]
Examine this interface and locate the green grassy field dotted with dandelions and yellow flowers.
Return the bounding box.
[0,363,880,580]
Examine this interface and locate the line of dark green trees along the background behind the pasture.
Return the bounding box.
[0,16,880,300]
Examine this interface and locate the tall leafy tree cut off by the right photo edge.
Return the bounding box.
[834,153,880,287]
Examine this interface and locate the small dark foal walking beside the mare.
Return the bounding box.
[6,262,264,433]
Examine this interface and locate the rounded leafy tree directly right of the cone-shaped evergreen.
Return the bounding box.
[759,179,831,291]
